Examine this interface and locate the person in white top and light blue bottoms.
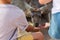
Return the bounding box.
[39,0,60,40]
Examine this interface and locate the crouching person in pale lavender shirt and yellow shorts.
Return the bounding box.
[0,0,44,40]
